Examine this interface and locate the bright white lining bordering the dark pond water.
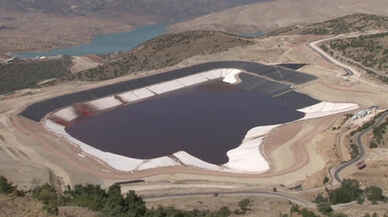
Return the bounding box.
[43,69,358,173]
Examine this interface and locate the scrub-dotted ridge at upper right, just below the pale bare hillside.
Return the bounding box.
[266,13,388,36]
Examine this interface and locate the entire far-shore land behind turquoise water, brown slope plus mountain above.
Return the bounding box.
[0,0,270,54]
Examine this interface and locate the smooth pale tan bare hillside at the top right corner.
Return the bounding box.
[171,0,388,32]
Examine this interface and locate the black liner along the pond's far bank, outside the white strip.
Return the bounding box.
[20,61,317,122]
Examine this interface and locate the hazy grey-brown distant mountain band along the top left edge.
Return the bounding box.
[0,0,270,22]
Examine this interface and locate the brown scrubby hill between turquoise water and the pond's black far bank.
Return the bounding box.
[65,31,253,81]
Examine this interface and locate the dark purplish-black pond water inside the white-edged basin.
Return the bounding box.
[67,80,310,164]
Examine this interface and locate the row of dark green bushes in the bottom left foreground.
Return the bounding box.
[0,177,232,217]
